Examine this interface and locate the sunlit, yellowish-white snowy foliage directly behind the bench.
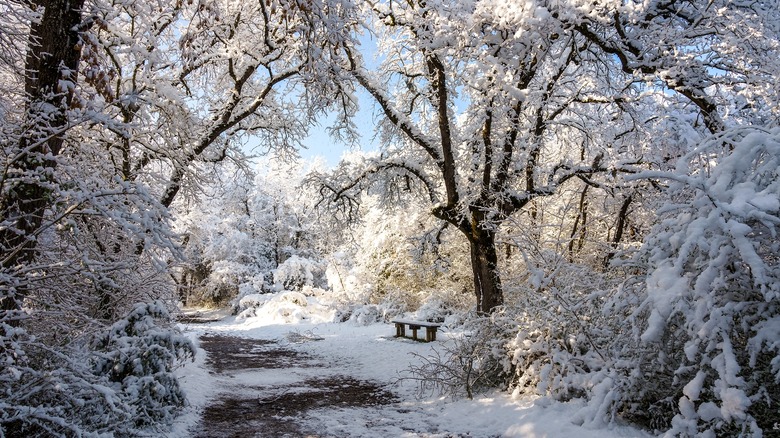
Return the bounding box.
[316,196,472,319]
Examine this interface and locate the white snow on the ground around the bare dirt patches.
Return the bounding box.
[173,298,650,438]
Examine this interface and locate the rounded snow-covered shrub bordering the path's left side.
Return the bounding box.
[93,302,195,427]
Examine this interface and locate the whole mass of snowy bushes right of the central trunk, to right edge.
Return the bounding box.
[494,128,780,436]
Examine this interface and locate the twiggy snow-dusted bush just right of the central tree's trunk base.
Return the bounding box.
[506,252,614,400]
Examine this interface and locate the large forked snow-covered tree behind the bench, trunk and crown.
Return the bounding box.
[314,1,656,312]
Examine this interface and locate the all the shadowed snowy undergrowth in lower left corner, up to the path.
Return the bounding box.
[0,303,194,437]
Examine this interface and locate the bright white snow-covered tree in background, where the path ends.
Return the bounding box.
[179,159,328,303]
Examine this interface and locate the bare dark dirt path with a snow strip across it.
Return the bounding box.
[193,333,396,438]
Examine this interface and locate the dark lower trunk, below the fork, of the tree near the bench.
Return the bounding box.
[469,230,504,315]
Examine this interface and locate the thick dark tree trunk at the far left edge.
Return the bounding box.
[0,0,84,314]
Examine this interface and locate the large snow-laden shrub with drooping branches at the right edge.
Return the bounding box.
[594,128,780,436]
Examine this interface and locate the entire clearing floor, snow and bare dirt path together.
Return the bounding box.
[172,308,649,438]
